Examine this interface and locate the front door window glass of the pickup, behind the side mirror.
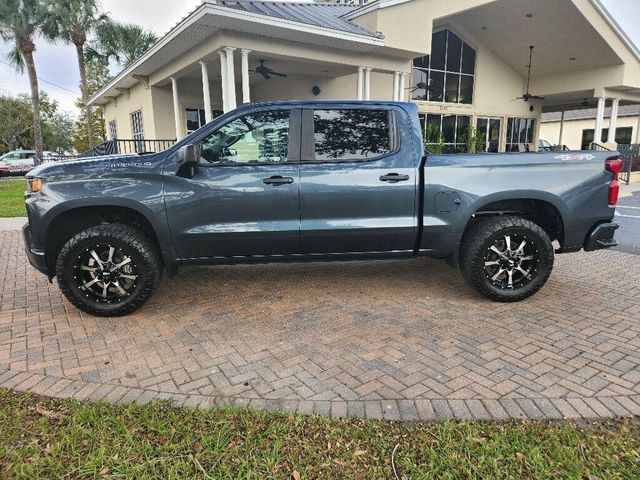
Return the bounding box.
[200,110,290,165]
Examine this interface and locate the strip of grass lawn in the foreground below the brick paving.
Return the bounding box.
[0,389,640,480]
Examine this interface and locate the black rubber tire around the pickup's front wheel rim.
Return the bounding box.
[56,224,162,317]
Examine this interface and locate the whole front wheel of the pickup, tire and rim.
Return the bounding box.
[56,224,162,317]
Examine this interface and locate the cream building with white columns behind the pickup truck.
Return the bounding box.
[90,0,640,151]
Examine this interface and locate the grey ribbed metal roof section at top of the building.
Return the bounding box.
[218,0,382,38]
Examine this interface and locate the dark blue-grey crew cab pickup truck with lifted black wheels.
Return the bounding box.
[23,101,621,316]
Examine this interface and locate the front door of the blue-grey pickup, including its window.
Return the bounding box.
[164,107,301,259]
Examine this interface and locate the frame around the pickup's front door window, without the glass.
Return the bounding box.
[191,107,301,168]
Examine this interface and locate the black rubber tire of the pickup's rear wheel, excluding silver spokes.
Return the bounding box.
[460,216,555,302]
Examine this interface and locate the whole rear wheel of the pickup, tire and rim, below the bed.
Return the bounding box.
[460,216,554,302]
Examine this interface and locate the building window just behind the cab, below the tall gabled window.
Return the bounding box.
[420,113,471,153]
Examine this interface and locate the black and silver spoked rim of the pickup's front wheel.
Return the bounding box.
[74,244,139,304]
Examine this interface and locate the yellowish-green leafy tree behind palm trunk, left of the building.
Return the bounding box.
[73,58,111,153]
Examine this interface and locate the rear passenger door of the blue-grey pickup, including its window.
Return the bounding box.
[300,105,420,254]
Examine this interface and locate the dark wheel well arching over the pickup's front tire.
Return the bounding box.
[46,206,161,272]
